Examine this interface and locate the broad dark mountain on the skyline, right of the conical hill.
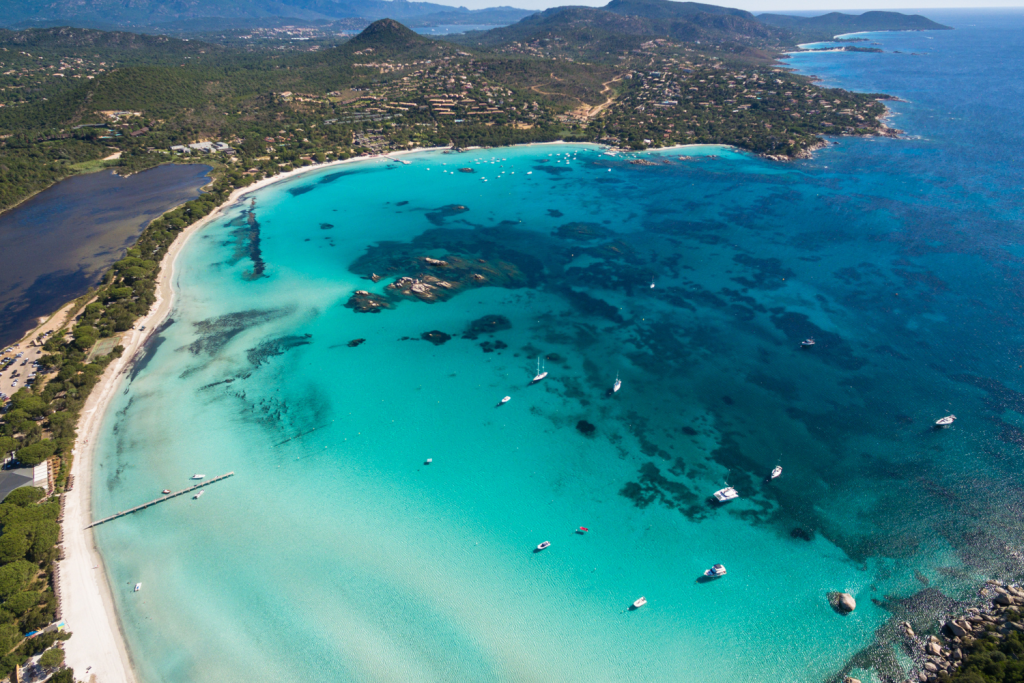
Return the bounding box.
[454,0,790,56]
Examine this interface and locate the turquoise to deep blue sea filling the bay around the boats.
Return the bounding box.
[90,13,1024,683]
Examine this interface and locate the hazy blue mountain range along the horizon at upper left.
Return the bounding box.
[0,0,532,30]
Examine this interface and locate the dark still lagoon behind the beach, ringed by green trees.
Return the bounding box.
[0,164,210,346]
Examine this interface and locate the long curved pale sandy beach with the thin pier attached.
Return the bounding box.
[58,147,445,683]
